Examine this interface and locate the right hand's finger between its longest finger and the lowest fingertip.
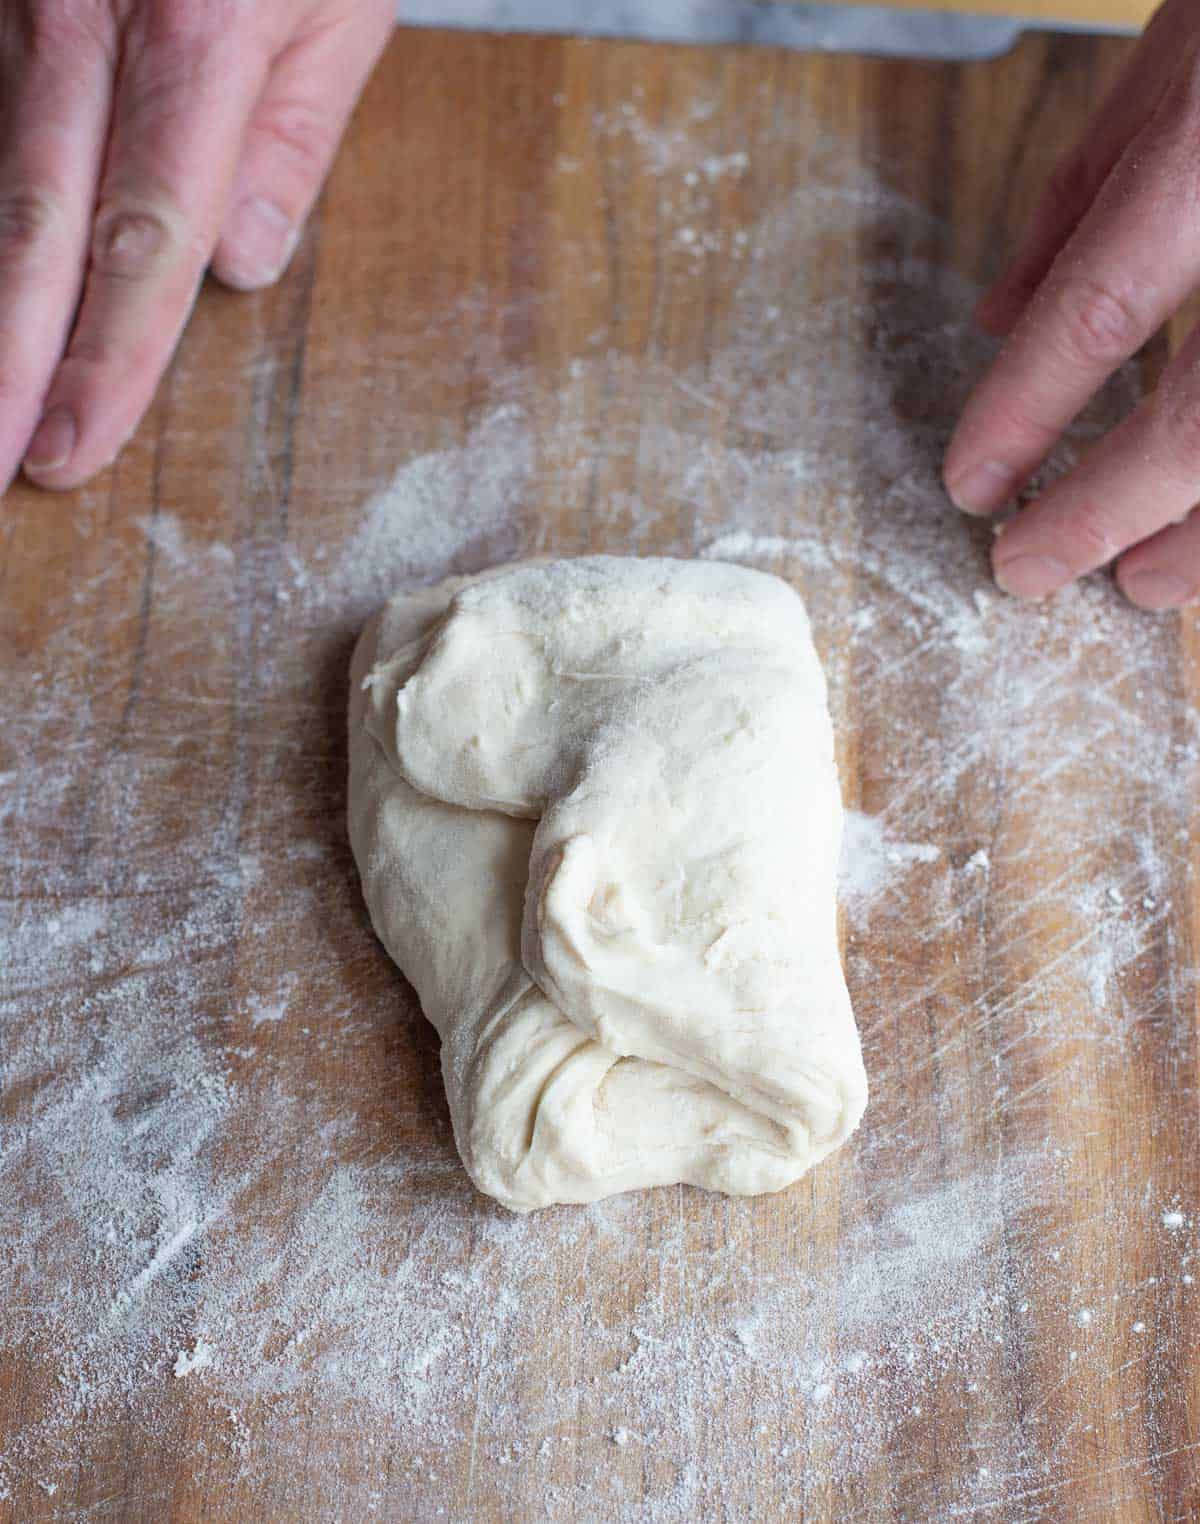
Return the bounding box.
[993,324,1200,597]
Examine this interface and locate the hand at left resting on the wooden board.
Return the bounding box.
[0,0,395,488]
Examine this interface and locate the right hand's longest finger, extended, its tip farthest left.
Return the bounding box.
[944,35,1200,514]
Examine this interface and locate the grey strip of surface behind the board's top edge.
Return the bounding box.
[399,0,1128,58]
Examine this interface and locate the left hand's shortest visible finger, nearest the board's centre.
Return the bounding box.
[212,0,393,290]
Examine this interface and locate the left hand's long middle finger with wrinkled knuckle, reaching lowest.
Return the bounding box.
[24,6,267,486]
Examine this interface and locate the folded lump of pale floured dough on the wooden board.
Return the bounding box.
[351,556,866,1212]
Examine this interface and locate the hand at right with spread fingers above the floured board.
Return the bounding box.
[944,0,1200,610]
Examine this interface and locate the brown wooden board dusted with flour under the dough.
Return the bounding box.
[0,23,1200,1524]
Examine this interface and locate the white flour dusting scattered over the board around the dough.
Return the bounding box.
[0,108,1200,1524]
